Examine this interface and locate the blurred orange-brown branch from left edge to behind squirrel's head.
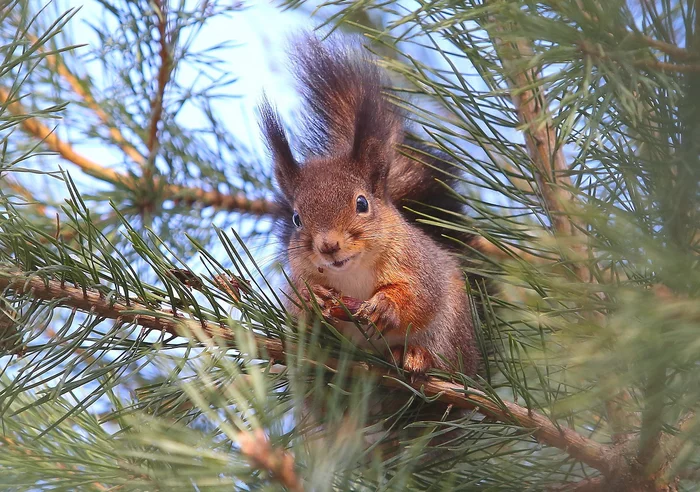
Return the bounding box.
[0,87,276,215]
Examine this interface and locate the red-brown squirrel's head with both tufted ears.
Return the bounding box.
[262,95,398,272]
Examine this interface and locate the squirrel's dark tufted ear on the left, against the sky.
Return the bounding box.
[260,98,299,198]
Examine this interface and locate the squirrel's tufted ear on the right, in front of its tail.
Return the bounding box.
[350,97,401,193]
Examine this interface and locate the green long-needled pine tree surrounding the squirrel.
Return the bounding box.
[0,0,700,491]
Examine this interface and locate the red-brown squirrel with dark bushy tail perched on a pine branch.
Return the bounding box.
[260,36,479,376]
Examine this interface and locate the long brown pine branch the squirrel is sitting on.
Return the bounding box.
[0,270,613,474]
